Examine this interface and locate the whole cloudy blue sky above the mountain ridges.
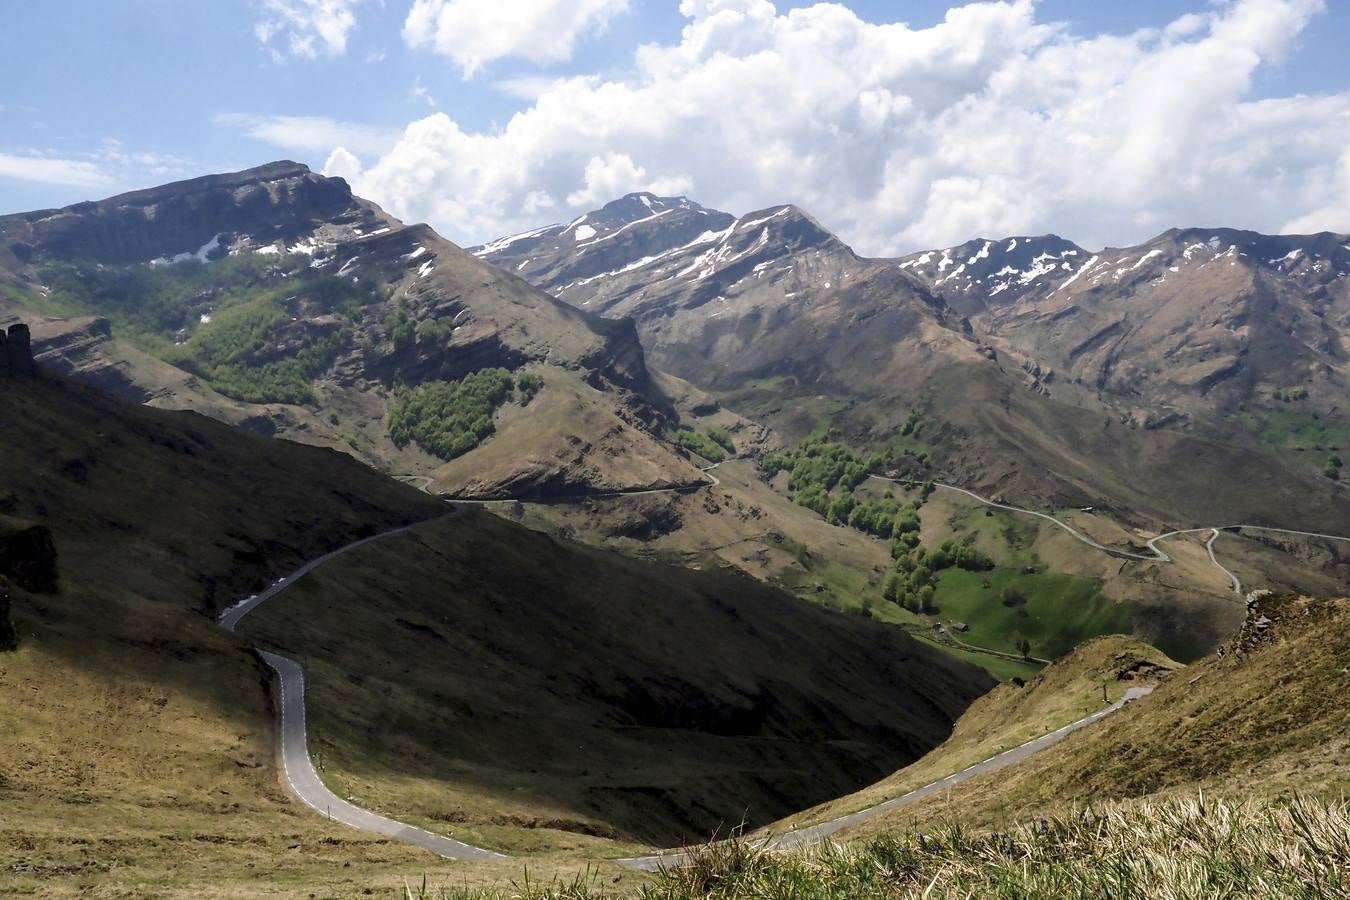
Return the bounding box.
[0,0,1350,251]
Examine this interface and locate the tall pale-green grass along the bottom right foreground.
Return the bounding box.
[407,795,1350,900]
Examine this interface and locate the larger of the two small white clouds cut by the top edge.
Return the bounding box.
[404,0,628,78]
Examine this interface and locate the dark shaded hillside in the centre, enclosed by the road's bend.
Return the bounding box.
[229,513,988,853]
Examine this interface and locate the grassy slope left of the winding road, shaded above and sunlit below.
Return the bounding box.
[0,382,569,896]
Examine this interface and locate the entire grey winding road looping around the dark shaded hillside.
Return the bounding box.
[219,463,1350,872]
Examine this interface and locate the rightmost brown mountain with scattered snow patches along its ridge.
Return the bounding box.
[899,228,1350,425]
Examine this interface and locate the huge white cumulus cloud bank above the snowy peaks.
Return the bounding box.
[331,0,1350,254]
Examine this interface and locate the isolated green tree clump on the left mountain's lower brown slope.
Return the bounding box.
[389,368,521,459]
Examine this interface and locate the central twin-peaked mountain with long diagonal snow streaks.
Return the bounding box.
[471,194,961,399]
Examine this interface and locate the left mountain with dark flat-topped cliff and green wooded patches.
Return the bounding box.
[0,162,702,495]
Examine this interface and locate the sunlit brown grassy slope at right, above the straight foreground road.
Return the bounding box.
[842,596,1350,834]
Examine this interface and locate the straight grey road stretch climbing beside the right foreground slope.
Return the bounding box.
[616,687,1153,872]
